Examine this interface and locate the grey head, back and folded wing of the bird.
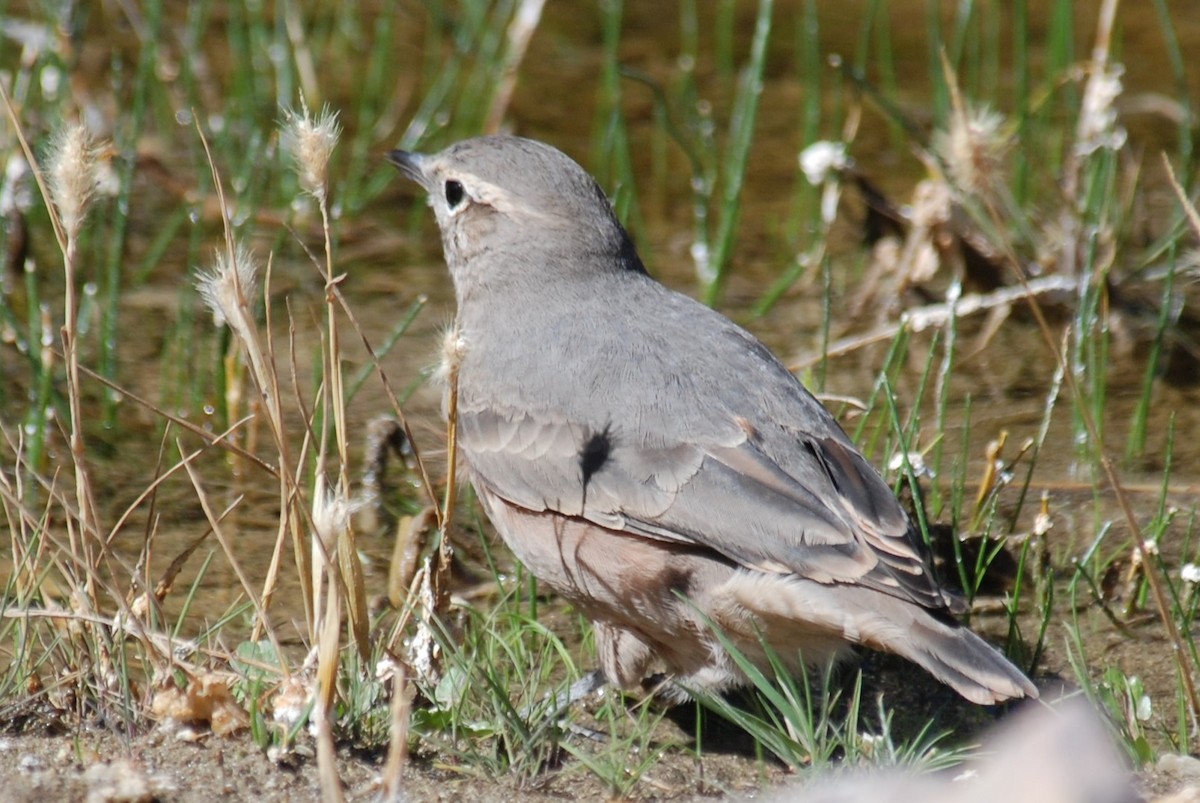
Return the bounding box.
[417,138,942,607]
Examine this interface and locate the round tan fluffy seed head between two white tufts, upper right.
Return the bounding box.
[934,108,1013,197]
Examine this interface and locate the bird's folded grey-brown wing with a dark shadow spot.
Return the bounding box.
[457,402,946,609]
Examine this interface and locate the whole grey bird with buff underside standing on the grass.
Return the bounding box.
[389,137,1038,703]
